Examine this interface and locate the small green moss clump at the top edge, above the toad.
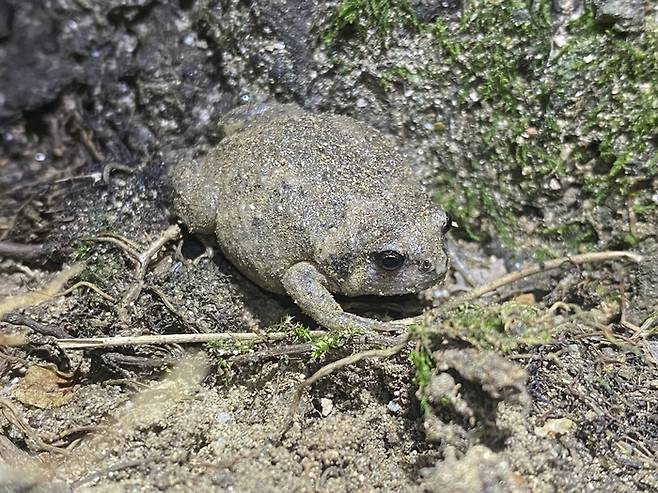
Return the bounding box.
[322,0,422,44]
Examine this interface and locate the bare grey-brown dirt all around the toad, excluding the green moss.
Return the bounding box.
[0,0,658,493]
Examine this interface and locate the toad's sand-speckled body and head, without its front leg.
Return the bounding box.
[173,105,450,314]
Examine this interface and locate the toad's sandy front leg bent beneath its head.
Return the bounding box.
[282,262,404,332]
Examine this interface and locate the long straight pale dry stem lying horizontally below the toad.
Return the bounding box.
[55,330,328,349]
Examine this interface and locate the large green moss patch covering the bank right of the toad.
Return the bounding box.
[326,0,658,246]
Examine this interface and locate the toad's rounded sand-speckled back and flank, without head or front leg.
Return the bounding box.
[175,109,433,292]
